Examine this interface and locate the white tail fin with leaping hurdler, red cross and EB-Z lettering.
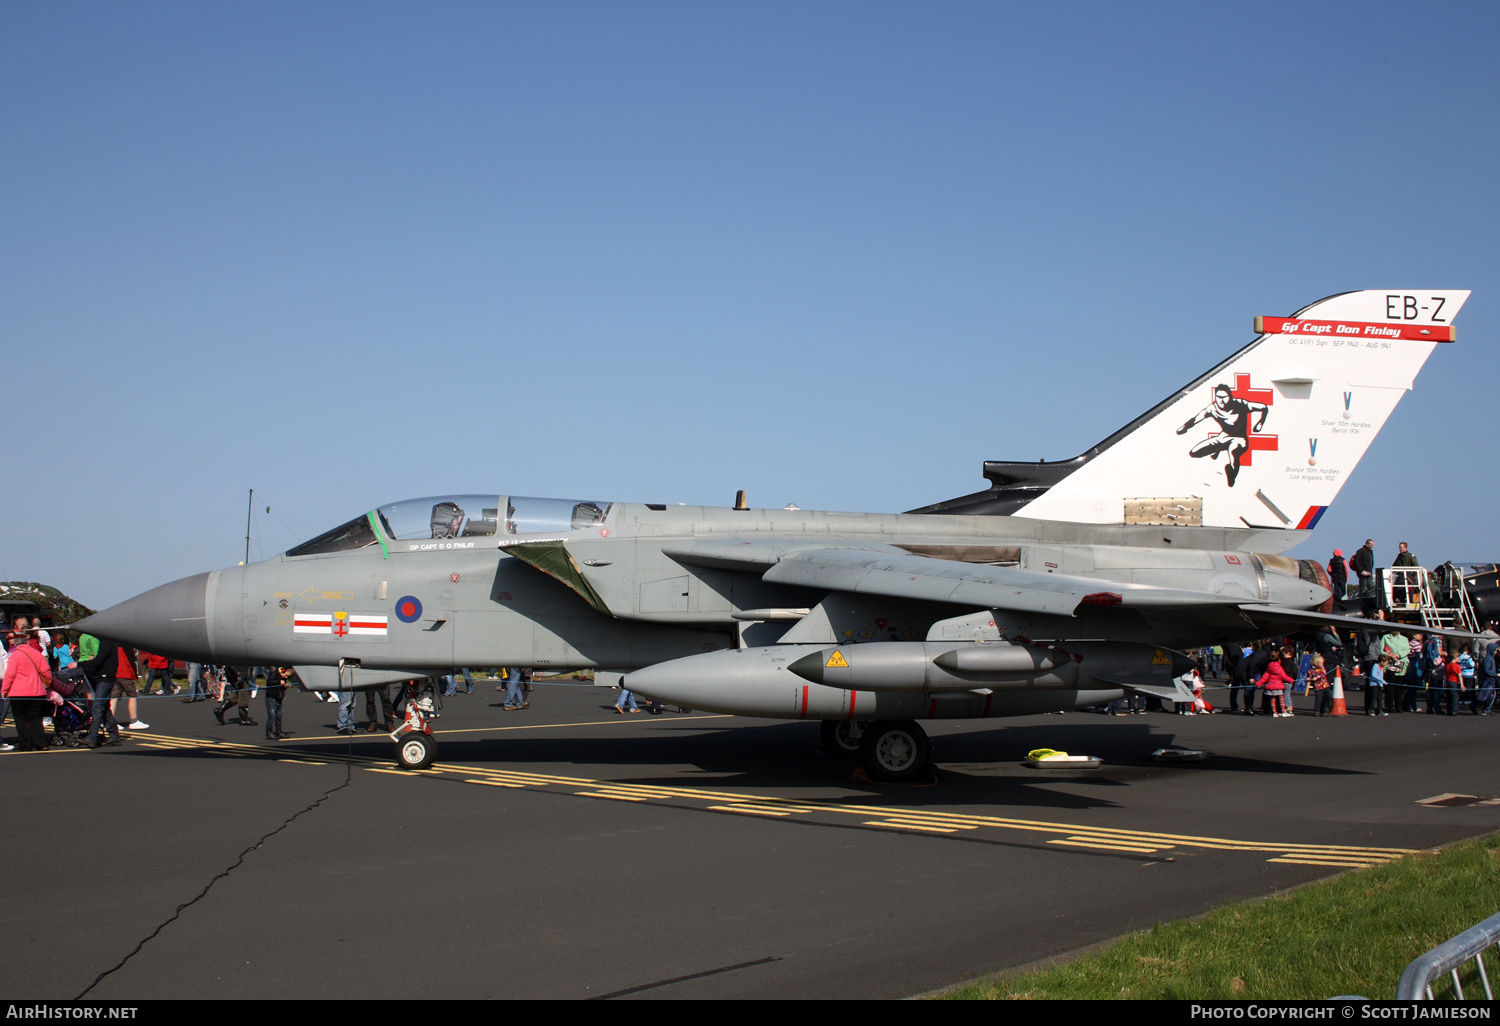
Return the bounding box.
[1016,290,1469,528]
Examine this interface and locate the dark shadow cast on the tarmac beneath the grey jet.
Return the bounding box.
[120,720,1365,810]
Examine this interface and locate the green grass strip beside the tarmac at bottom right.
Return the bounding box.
[939,837,1500,999]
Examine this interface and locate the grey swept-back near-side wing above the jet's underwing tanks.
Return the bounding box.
[762,549,1245,617]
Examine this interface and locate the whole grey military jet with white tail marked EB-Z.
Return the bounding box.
[78,290,1469,780]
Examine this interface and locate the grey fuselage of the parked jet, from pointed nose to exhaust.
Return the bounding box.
[83,497,1329,719]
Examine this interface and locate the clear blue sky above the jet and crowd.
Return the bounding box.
[0,0,1500,606]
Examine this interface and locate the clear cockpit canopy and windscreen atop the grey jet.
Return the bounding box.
[287,495,614,557]
